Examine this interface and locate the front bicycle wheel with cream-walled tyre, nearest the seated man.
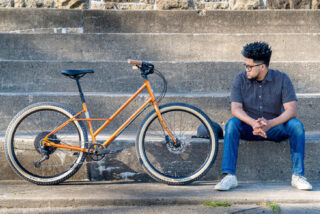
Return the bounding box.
[136,103,218,185]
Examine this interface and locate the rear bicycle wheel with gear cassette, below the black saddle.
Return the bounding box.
[5,103,88,184]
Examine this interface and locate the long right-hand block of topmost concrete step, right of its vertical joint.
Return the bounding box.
[84,10,319,33]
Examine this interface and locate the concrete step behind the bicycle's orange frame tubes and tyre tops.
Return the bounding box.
[0,92,320,133]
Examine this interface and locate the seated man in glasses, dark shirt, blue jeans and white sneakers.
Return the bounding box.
[215,42,312,190]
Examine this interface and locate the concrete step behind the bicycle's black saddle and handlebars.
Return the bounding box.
[0,61,320,93]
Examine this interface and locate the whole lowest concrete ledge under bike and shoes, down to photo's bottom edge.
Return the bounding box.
[0,180,320,209]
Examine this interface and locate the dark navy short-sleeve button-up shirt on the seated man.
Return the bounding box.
[230,69,297,120]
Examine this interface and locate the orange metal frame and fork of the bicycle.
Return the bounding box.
[43,79,176,152]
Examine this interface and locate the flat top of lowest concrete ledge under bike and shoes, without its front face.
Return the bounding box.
[0,181,320,209]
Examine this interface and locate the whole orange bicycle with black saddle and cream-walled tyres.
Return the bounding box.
[5,60,218,185]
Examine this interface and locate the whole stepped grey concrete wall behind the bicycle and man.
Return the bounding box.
[0,9,320,181]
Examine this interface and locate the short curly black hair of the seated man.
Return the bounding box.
[241,42,272,67]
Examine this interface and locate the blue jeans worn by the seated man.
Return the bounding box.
[222,118,305,176]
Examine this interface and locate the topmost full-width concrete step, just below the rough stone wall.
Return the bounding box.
[0,8,320,33]
